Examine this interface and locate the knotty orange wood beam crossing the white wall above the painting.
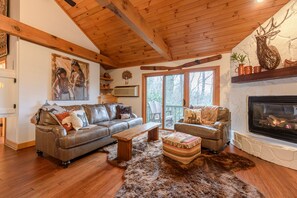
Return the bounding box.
[0,15,116,67]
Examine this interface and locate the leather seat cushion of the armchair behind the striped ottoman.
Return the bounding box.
[174,123,222,140]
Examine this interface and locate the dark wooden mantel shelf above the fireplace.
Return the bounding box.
[231,67,297,83]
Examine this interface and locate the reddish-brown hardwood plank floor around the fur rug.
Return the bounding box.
[0,145,297,198]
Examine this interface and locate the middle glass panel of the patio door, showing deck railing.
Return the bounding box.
[164,74,184,129]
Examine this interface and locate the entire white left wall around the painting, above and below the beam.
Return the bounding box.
[7,0,100,143]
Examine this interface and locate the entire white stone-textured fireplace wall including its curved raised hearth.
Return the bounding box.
[229,0,297,170]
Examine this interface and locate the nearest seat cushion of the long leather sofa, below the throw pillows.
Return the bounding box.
[59,126,109,149]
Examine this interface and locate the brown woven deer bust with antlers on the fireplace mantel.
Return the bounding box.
[255,10,290,70]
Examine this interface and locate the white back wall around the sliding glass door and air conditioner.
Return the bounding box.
[110,53,230,116]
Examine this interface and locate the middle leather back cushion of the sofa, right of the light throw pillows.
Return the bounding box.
[83,104,109,124]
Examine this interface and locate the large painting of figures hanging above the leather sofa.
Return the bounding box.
[51,54,89,101]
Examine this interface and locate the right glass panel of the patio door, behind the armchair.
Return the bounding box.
[189,71,214,106]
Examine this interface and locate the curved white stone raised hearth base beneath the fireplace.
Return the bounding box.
[231,131,297,170]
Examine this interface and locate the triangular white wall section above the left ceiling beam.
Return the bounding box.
[20,0,99,52]
